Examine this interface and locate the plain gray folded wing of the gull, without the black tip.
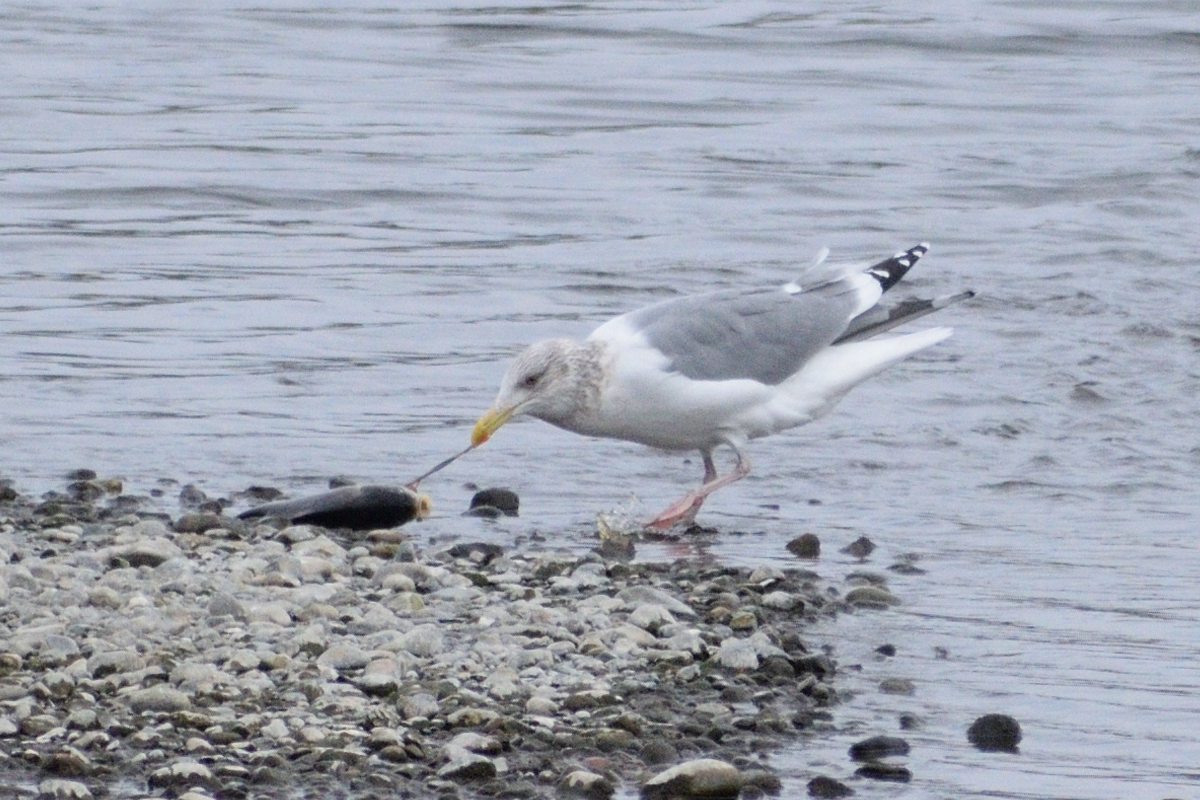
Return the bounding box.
[625,279,862,385]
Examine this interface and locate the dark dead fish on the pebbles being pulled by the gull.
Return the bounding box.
[238,486,431,530]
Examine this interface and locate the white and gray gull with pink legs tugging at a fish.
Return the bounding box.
[463,243,974,529]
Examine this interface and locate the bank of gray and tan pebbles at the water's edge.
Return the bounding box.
[0,480,890,800]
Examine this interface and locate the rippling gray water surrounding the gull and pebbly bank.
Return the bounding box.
[0,0,1200,798]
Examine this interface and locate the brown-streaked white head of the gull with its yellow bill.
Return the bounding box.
[470,339,587,447]
